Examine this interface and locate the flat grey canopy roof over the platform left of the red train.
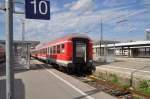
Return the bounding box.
[0,40,40,47]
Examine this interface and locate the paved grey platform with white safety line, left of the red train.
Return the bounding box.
[0,60,115,99]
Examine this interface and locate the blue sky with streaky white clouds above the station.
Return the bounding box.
[0,0,150,42]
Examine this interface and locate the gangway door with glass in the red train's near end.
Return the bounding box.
[73,39,88,64]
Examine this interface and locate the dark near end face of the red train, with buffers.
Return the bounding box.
[68,37,95,74]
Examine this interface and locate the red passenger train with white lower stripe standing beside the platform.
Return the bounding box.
[31,36,95,73]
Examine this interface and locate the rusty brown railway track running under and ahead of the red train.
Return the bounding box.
[32,60,150,99]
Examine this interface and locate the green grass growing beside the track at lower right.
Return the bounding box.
[92,72,150,99]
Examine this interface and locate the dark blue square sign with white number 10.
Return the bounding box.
[25,0,50,20]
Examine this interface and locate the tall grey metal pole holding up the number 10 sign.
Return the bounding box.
[5,0,14,99]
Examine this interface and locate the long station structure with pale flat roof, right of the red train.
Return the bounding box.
[93,40,150,58]
